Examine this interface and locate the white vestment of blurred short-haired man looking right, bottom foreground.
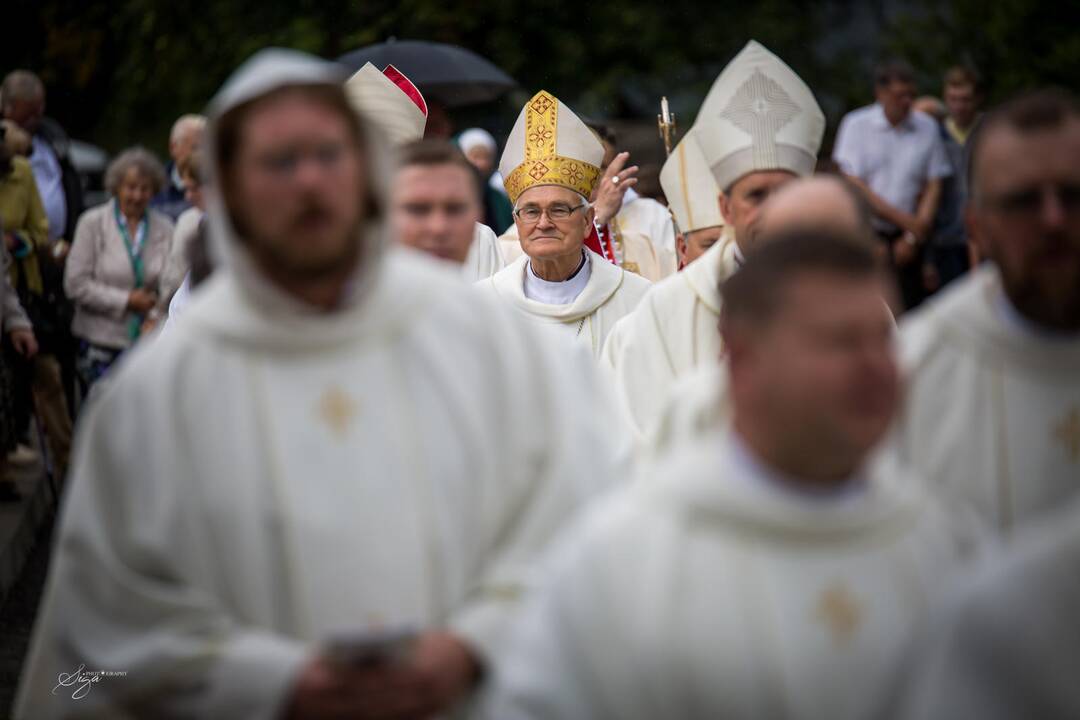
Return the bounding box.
[487,434,980,720]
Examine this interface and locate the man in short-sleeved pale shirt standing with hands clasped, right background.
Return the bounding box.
[833,60,953,308]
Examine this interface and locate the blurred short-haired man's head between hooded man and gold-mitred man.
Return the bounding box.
[391,140,483,263]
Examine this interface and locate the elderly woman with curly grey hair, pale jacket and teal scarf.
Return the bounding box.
[64,148,173,390]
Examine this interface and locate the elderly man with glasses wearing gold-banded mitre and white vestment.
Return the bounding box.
[477,91,649,357]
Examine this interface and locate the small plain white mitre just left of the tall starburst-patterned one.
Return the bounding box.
[660,127,724,233]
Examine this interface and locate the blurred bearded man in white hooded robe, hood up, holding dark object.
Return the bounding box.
[16,50,626,720]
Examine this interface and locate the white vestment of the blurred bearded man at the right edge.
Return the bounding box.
[895,267,1080,534]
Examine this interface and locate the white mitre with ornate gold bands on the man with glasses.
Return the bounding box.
[499,90,604,203]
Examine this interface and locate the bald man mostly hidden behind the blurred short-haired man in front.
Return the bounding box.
[640,175,895,457]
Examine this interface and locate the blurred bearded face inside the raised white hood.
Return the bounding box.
[227,92,367,279]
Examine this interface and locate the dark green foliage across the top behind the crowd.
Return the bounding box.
[0,0,1080,152]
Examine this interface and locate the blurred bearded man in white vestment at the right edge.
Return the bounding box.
[899,92,1080,533]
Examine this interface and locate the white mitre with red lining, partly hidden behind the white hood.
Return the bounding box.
[345,63,428,146]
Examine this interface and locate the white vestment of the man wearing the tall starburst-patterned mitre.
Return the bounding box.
[602,227,739,437]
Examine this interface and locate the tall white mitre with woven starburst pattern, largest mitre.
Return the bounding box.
[694,40,825,190]
